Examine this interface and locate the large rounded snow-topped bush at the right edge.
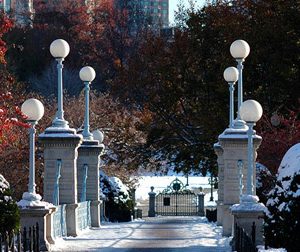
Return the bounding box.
[265,144,300,252]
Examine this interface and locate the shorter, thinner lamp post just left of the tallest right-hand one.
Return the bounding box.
[223,67,239,128]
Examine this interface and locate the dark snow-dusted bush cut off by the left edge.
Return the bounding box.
[0,174,20,233]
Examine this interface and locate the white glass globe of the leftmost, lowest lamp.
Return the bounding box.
[21,98,44,121]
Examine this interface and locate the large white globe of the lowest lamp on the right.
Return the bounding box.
[239,100,263,123]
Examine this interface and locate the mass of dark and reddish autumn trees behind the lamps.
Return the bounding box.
[0,0,300,199]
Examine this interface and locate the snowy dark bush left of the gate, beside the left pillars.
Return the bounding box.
[100,171,133,222]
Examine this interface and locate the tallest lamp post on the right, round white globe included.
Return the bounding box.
[230,39,250,128]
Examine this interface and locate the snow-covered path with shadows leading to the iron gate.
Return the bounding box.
[55,217,231,252]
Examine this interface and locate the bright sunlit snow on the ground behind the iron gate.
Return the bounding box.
[135,176,218,206]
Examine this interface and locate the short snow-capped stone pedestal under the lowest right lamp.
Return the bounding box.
[231,195,266,246]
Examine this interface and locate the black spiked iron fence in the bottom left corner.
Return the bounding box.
[0,223,40,252]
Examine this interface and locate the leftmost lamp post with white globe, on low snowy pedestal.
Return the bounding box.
[21,99,44,199]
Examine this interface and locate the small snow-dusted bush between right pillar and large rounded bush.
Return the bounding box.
[256,163,276,204]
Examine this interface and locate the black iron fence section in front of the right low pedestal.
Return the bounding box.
[234,222,257,252]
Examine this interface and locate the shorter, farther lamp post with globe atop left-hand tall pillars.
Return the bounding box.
[79,66,96,140]
